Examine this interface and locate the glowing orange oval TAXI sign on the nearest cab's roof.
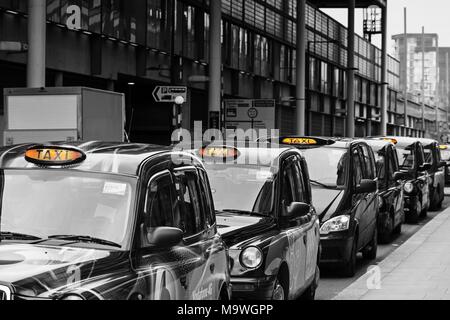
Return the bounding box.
[25,146,86,166]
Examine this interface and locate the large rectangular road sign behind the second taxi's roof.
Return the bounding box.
[225,99,275,130]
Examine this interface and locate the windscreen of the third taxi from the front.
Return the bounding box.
[302,148,348,188]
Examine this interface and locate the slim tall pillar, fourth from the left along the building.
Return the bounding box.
[347,0,355,138]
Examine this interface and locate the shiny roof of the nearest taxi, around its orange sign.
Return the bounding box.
[0,141,178,176]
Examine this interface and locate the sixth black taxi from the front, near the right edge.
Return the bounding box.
[419,139,447,210]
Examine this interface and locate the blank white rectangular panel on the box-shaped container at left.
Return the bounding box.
[6,95,78,130]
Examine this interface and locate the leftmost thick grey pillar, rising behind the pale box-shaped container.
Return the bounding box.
[27,0,47,88]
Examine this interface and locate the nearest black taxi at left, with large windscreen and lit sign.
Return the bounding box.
[0,142,231,300]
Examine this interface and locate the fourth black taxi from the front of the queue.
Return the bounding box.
[365,139,409,243]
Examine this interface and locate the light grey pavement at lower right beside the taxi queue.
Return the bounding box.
[334,198,450,300]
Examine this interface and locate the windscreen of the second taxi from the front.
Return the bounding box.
[206,164,274,215]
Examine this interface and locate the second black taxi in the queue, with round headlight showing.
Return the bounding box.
[194,145,320,300]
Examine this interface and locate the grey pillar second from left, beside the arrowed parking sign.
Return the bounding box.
[208,0,222,129]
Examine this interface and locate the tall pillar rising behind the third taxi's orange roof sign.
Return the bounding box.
[296,0,306,136]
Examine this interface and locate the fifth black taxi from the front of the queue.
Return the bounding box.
[382,137,431,223]
